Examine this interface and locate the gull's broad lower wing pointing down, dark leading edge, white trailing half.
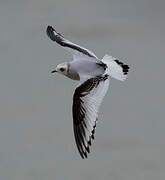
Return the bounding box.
[72,75,109,158]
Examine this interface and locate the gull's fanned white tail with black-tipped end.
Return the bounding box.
[102,54,129,81]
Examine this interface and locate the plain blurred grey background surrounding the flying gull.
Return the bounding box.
[0,0,165,180]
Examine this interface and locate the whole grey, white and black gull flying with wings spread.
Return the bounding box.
[46,26,129,159]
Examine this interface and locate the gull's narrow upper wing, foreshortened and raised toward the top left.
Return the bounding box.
[46,26,97,59]
